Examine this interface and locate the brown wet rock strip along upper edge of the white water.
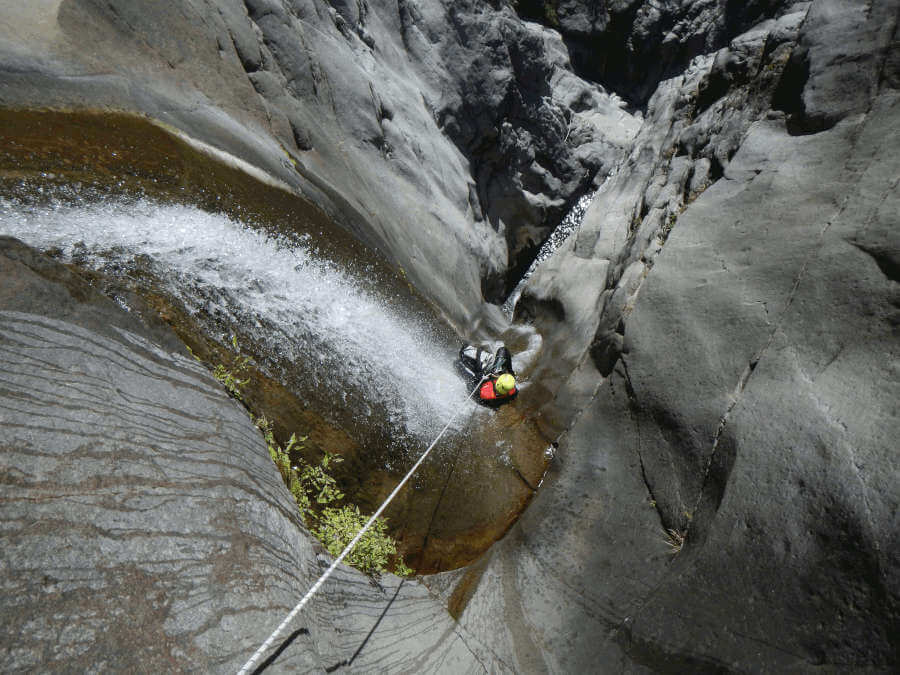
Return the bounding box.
[0,109,372,270]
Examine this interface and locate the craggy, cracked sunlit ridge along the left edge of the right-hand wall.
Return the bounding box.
[517,4,808,433]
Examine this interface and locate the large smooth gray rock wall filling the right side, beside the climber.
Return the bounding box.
[486,1,900,672]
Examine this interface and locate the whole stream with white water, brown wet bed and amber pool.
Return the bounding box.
[0,111,549,573]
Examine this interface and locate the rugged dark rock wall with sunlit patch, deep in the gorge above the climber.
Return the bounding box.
[400,1,637,303]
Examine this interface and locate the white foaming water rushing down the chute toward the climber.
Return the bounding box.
[0,199,474,439]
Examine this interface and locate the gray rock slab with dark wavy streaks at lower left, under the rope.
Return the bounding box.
[0,239,482,672]
